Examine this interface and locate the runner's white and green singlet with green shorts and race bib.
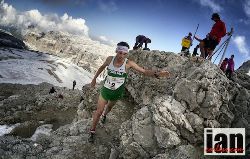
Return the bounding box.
[101,56,128,101]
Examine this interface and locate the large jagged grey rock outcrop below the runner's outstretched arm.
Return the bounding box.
[121,51,234,157]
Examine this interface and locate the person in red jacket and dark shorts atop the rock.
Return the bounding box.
[195,13,227,59]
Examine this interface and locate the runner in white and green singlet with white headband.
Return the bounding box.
[89,42,170,142]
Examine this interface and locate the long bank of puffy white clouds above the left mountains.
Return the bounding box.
[0,1,89,36]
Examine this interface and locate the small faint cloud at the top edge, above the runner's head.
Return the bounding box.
[98,0,118,13]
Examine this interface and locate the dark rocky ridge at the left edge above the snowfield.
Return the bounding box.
[0,29,26,49]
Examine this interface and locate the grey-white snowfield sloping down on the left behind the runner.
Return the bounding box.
[0,48,93,89]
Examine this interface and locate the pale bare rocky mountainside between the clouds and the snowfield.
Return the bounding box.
[24,31,115,73]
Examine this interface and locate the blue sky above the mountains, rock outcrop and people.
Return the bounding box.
[0,0,250,68]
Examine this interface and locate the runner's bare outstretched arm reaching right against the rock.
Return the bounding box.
[127,60,170,77]
